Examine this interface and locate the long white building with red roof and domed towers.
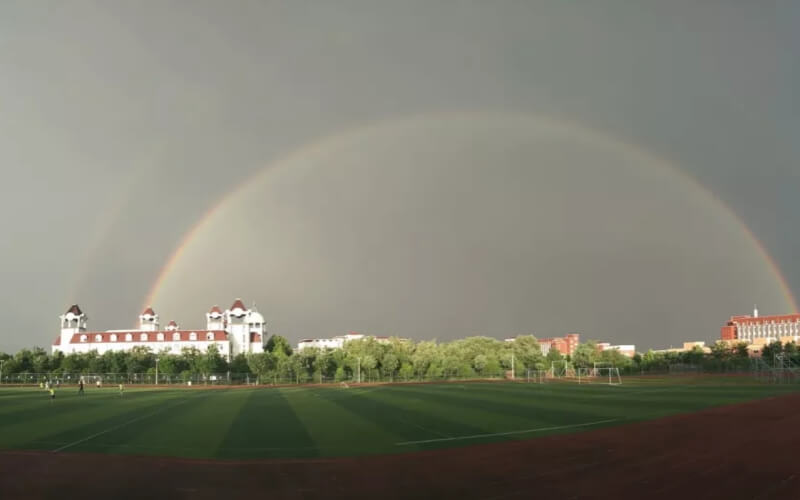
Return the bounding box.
[52,299,266,359]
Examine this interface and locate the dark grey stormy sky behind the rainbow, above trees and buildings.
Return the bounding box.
[0,1,800,350]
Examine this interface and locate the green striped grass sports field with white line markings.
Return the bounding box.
[0,377,796,459]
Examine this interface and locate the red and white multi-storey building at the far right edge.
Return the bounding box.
[720,308,800,344]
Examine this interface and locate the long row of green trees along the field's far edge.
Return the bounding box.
[0,335,800,383]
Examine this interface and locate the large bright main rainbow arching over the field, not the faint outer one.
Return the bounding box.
[142,111,798,313]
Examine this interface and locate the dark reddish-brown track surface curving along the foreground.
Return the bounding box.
[0,394,800,500]
